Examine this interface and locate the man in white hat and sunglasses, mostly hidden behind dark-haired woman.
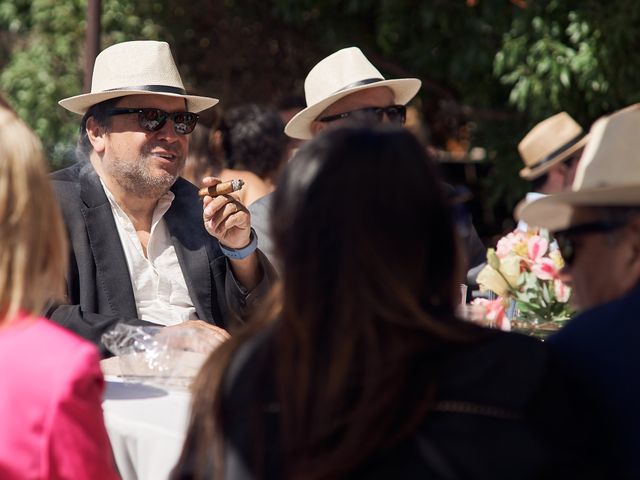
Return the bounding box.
[250,47,485,278]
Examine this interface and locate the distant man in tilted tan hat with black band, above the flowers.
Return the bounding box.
[518,112,588,231]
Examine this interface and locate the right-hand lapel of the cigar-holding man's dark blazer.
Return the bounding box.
[164,178,213,323]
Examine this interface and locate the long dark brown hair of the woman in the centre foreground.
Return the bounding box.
[172,127,482,479]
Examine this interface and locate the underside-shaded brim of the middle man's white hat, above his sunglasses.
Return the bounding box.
[284,78,422,140]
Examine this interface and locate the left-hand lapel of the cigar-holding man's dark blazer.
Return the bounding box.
[80,163,138,318]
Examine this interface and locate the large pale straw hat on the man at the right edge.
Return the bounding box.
[516,103,640,231]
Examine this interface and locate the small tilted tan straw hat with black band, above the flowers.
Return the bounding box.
[518,112,588,180]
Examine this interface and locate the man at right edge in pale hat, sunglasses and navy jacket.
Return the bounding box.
[517,104,640,478]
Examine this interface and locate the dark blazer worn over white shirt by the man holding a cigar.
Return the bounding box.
[48,161,274,353]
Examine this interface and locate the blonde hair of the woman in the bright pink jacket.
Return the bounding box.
[0,96,67,323]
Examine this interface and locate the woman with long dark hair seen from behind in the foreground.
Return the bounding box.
[172,126,584,480]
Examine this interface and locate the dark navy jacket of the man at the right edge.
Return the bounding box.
[547,286,640,478]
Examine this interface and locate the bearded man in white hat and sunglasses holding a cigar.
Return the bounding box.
[50,41,271,352]
